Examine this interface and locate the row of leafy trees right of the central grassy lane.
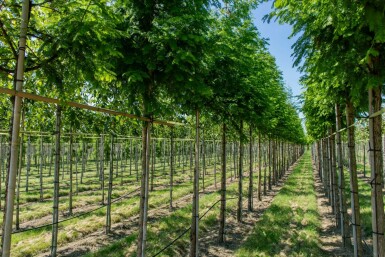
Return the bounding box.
[267,0,385,256]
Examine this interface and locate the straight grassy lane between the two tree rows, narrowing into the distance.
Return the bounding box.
[236,152,326,256]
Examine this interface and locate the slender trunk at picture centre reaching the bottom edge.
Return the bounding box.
[190,110,200,257]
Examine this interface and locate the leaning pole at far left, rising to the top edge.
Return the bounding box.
[2,0,30,252]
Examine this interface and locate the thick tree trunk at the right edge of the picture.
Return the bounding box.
[369,85,385,257]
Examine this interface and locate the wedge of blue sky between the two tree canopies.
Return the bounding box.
[253,1,302,101]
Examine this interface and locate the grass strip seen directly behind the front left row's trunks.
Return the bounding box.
[86,168,247,257]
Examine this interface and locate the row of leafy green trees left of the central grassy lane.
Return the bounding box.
[0,0,304,256]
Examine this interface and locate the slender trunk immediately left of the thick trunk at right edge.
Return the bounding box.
[346,99,363,256]
